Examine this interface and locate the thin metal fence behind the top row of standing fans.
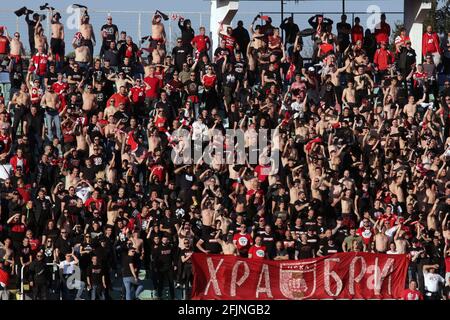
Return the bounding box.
[0,7,403,56]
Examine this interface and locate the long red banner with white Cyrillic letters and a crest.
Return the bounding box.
[192,252,408,300]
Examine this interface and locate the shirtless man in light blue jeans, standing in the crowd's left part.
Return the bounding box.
[41,85,62,141]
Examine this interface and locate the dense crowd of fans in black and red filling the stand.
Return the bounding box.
[0,7,450,300]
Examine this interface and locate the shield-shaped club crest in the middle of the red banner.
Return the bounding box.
[280,262,317,300]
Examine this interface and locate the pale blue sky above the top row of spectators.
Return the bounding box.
[0,0,403,53]
